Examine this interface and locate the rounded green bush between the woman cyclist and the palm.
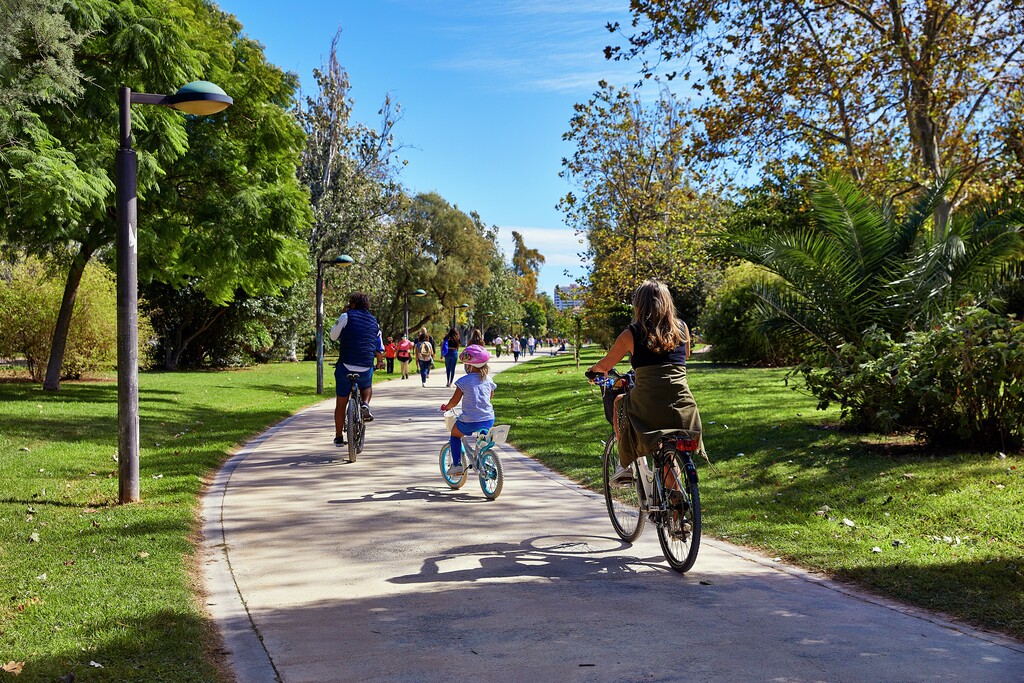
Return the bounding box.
[700,263,800,366]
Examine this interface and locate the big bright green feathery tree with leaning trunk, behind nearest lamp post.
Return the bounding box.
[3,0,309,390]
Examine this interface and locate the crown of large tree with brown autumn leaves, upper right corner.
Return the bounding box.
[605,0,1024,237]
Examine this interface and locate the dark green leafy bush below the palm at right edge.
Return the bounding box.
[801,308,1024,450]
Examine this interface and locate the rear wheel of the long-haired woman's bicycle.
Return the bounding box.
[655,453,700,573]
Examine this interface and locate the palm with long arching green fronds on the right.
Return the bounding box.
[729,173,1024,356]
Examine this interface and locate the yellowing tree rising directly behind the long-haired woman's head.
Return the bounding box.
[559,82,720,339]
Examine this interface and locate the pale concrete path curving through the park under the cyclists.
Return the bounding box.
[204,356,1024,683]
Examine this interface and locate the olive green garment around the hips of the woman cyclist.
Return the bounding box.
[618,364,700,467]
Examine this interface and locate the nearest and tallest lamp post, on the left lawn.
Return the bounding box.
[114,81,233,503]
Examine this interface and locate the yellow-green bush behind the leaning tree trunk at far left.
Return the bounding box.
[0,258,152,382]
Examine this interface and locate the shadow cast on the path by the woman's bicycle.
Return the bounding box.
[388,536,673,585]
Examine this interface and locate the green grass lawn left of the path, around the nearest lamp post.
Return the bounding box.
[0,362,333,682]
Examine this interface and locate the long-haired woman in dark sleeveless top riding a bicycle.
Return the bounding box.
[590,280,701,483]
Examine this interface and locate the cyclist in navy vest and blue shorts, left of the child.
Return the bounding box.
[331,292,384,445]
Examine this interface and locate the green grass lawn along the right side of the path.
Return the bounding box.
[495,350,1024,639]
